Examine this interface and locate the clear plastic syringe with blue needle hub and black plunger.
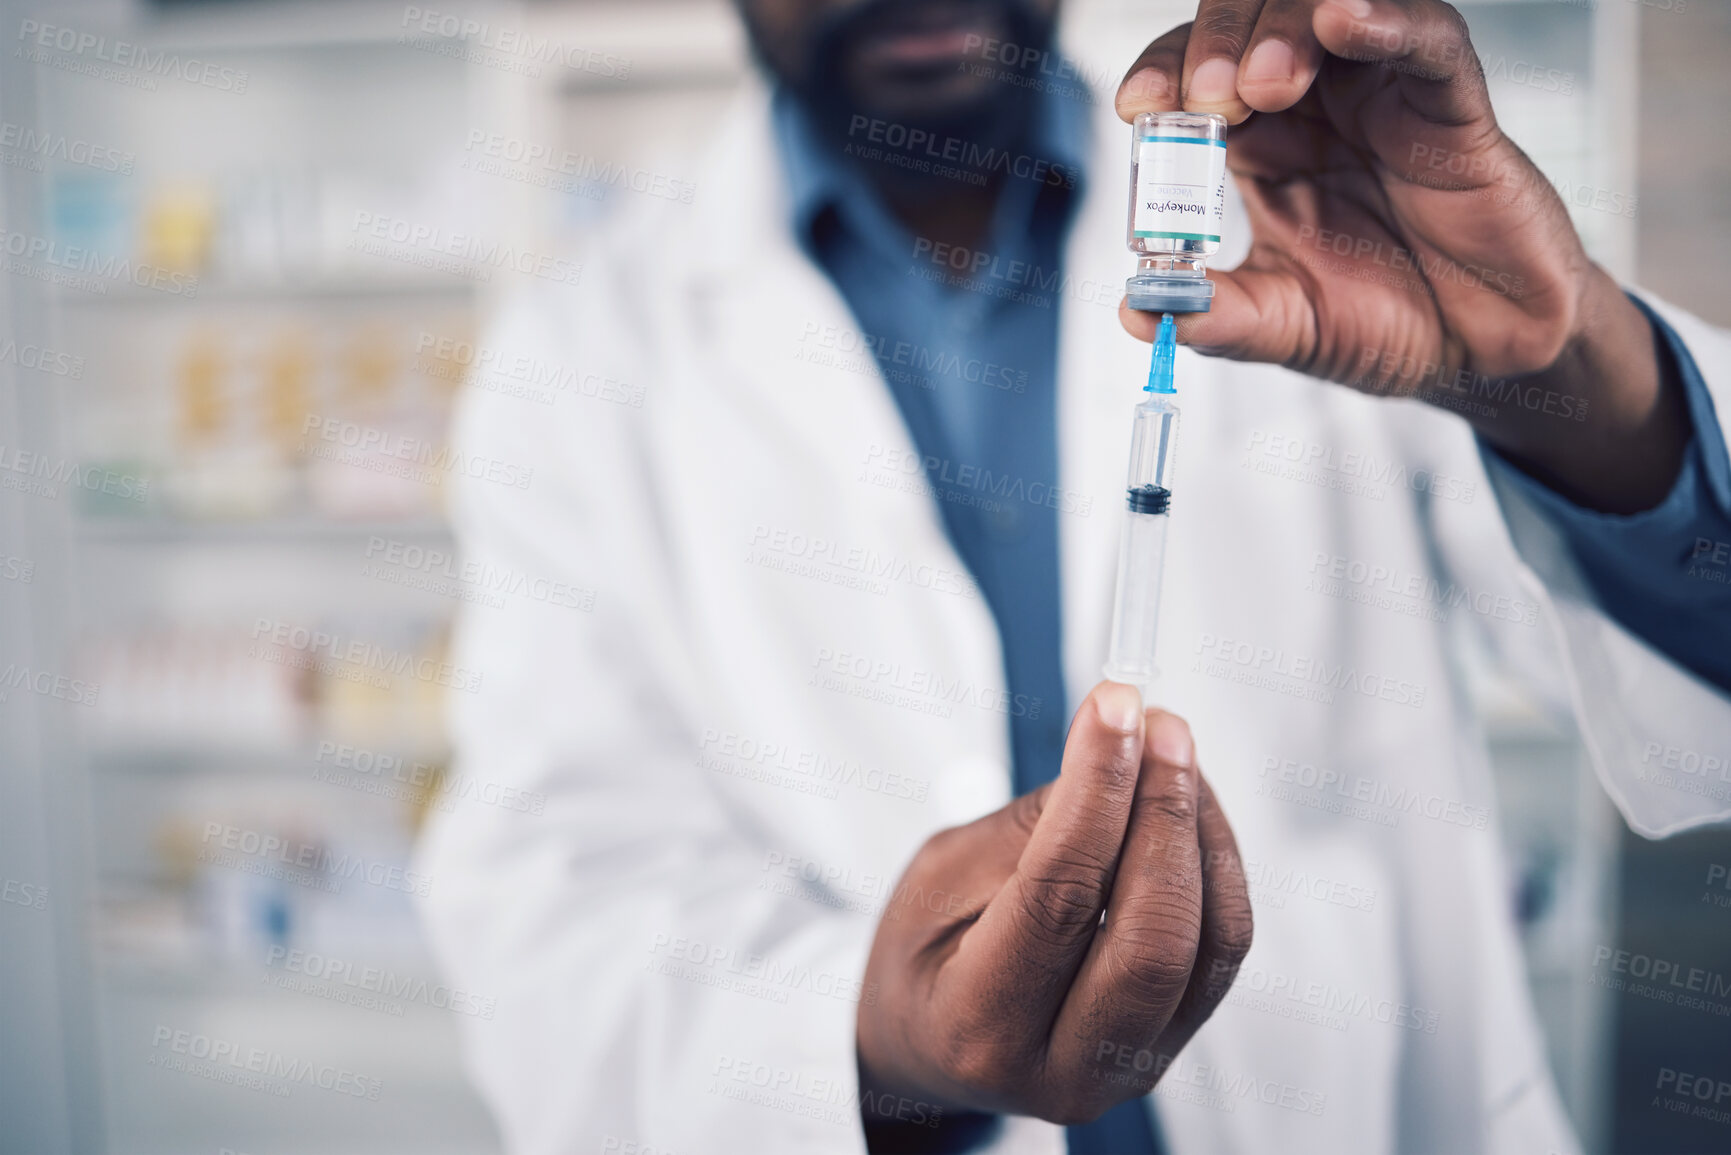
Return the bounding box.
[1106,313,1179,693]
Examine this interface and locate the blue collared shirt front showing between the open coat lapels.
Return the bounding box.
[774,90,1091,793]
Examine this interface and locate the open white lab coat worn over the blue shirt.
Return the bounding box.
[421,74,1731,1155]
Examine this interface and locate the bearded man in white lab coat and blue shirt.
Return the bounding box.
[422,0,1731,1155]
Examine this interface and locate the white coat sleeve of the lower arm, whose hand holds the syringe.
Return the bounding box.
[419,294,874,1155]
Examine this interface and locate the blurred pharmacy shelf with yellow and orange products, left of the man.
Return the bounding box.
[0,0,514,1155]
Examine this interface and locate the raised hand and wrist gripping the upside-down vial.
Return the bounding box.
[1116,0,1689,513]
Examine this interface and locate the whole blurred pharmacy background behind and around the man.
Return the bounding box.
[0,0,1731,1155]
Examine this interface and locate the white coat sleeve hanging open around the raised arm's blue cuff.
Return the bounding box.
[1485,298,1731,838]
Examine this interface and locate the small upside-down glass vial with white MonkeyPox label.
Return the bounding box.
[1123,113,1226,313]
